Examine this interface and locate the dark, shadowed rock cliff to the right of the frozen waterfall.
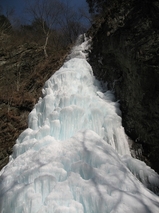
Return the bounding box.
[88,0,159,172]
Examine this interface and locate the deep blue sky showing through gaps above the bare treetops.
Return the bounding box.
[0,0,87,22]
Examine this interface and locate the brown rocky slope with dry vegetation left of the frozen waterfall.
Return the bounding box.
[0,33,68,169]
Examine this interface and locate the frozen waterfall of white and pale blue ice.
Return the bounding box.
[0,35,159,213]
